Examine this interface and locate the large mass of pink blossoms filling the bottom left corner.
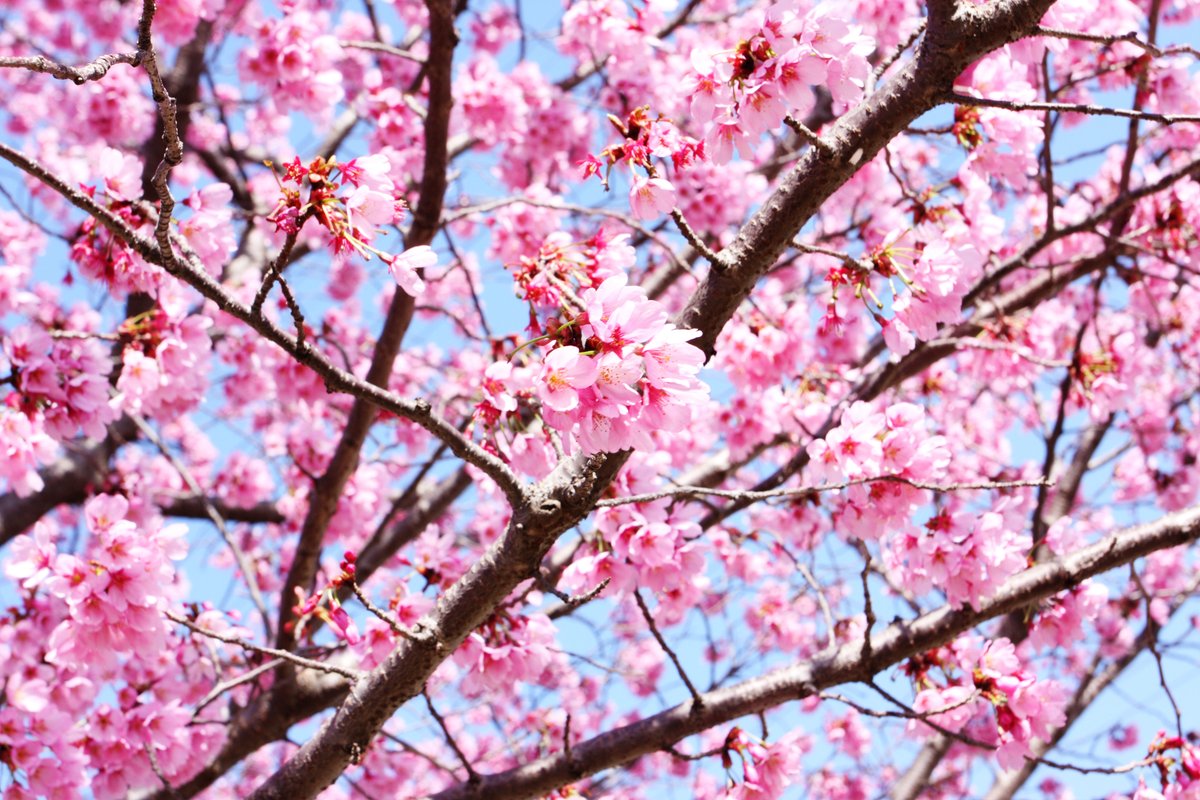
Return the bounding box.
[0,494,206,800]
